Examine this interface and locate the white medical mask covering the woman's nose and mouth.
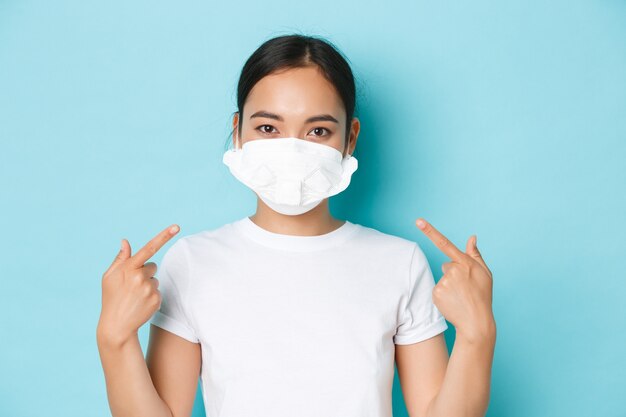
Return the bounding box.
[222,137,358,216]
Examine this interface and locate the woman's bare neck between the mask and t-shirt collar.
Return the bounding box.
[250,197,345,236]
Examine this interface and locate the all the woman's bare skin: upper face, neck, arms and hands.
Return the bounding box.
[97,67,495,417]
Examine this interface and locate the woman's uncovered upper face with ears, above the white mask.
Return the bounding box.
[233,66,360,156]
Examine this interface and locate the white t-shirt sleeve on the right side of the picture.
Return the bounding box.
[393,243,448,345]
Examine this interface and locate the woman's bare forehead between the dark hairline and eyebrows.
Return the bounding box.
[244,66,345,121]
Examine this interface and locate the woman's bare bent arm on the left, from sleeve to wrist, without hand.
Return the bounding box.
[97,325,201,417]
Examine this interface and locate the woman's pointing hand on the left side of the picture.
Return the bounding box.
[97,225,180,346]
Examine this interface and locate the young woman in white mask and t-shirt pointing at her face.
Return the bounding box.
[97,35,495,417]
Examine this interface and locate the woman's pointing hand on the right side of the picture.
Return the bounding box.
[415,218,495,342]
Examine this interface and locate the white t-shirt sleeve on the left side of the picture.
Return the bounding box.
[150,239,199,343]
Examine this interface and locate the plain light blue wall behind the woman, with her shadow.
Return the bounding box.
[0,0,626,417]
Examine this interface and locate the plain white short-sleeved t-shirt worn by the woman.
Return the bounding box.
[150,217,448,417]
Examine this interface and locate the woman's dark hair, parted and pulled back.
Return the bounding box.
[231,34,356,152]
